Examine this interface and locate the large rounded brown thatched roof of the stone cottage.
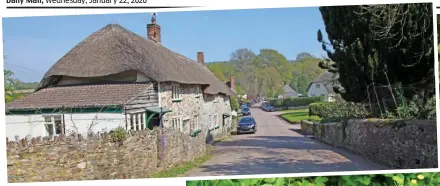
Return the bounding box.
[38,24,234,95]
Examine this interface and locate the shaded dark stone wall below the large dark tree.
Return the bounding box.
[301,119,438,169]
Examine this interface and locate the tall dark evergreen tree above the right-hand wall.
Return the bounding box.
[318,3,434,102]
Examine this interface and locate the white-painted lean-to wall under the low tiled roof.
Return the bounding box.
[6,113,125,140]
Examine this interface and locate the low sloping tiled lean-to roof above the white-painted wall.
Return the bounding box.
[6,83,153,110]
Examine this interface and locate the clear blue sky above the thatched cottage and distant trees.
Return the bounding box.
[3,7,326,82]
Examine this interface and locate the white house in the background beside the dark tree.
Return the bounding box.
[307,72,338,102]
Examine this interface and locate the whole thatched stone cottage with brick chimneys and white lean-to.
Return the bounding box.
[6,14,232,139]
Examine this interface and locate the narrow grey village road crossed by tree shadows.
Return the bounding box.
[184,105,389,177]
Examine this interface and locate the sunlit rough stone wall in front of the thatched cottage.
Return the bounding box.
[7,128,206,182]
